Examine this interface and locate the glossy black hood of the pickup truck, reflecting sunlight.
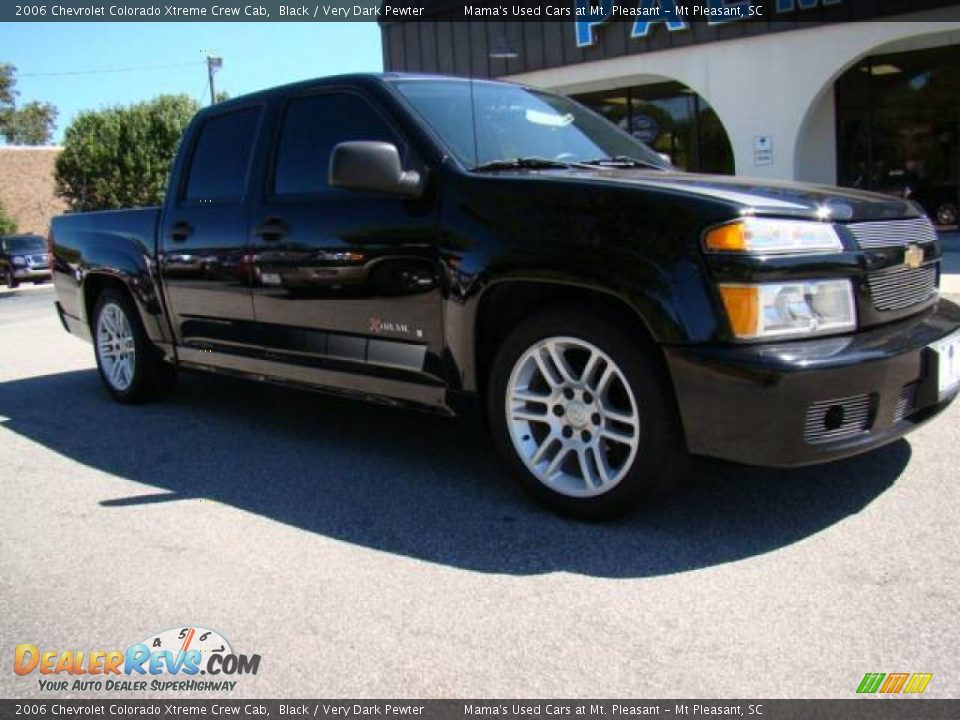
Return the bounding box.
[512,167,922,222]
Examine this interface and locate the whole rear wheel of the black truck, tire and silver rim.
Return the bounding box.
[93,289,176,404]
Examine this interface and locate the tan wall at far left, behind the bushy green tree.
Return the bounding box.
[0,147,67,236]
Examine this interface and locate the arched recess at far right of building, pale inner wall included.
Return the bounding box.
[795,28,960,227]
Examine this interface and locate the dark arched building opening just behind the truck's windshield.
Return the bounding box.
[572,80,734,174]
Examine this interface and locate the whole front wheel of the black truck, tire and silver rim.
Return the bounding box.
[488,310,686,519]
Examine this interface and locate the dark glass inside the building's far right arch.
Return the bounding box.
[834,45,960,226]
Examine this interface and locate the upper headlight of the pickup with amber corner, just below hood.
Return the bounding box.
[703,218,843,255]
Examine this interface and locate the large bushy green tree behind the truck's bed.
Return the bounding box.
[56,95,200,211]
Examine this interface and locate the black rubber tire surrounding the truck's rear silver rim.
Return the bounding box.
[91,288,176,405]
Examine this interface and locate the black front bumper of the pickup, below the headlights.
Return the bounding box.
[664,300,960,467]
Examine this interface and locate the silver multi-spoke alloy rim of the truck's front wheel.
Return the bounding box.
[506,337,640,497]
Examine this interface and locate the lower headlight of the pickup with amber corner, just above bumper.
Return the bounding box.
[720,280,857,340]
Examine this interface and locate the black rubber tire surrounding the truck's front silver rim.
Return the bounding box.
[487,309,688,520]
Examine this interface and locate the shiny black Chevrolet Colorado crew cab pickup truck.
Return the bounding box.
[52,74,960,517]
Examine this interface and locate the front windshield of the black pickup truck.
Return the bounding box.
[394,80,669,168]
